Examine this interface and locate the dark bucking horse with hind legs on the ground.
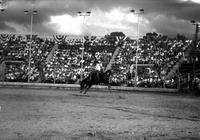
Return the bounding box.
[80,70,111,94]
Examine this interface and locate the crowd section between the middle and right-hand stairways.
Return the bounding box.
[111,33,192,87]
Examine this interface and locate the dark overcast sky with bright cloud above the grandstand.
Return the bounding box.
[0,0,200,36]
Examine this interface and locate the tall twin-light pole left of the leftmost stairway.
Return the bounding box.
[24,10,37,83]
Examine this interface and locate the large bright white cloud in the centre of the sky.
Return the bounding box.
[47,8,149,36]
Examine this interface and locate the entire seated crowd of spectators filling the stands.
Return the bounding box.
[0,33,198,87]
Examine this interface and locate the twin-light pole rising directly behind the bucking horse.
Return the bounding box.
[77,11,91,81]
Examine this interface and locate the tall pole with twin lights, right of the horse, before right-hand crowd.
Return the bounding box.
[131,9,144,87]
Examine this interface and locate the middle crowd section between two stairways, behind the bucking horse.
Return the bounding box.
[45,38,115,83]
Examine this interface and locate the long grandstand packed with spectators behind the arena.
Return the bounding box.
[0,33,200,91]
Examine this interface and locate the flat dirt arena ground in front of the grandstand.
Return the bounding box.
[0,88,200,140]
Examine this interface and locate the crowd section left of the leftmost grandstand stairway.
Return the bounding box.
[0,35,55,82]
